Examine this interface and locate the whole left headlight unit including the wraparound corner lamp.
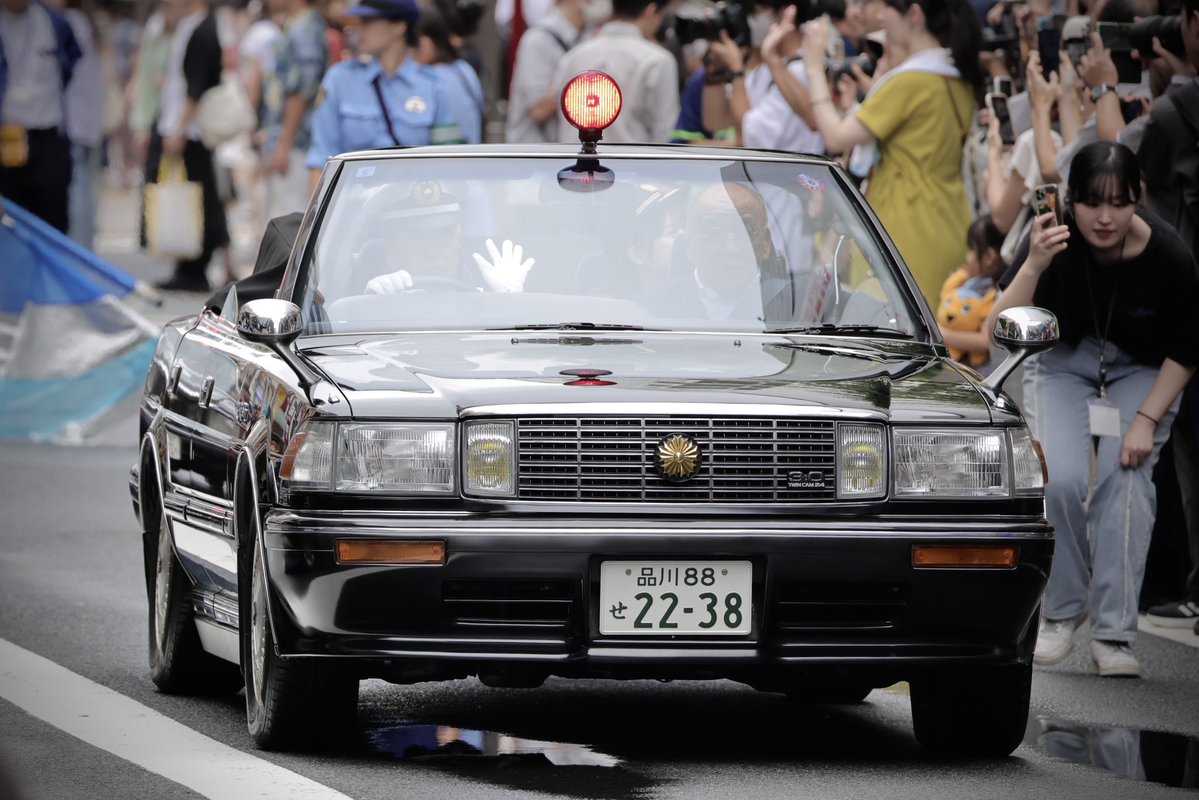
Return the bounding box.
[279,422,456,494]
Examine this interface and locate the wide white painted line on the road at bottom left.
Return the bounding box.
[0,639,350,800]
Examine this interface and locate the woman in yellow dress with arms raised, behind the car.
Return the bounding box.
[803,0,982,307]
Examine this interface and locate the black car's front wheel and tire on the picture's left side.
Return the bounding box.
[239,513,359,750]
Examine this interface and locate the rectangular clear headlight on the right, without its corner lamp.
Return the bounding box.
[892,428,1010,498]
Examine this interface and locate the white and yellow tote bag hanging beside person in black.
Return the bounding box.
[145,155,204,260]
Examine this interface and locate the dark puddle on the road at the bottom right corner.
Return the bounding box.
[1024,716,1199,789]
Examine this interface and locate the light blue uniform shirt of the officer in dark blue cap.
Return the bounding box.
[306,59,462,169]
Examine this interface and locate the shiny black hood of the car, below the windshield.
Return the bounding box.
[303,331,992,423]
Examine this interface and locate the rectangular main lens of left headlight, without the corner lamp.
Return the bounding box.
[335,423,454,494]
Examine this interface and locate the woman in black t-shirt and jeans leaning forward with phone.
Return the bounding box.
[988,142,1199,676]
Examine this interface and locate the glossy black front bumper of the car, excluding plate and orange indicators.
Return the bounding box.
[264,511,1053,682]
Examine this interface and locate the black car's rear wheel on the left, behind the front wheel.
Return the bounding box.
[145,503,241,694]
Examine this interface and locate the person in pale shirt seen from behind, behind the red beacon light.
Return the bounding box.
[553,0,679,143]
